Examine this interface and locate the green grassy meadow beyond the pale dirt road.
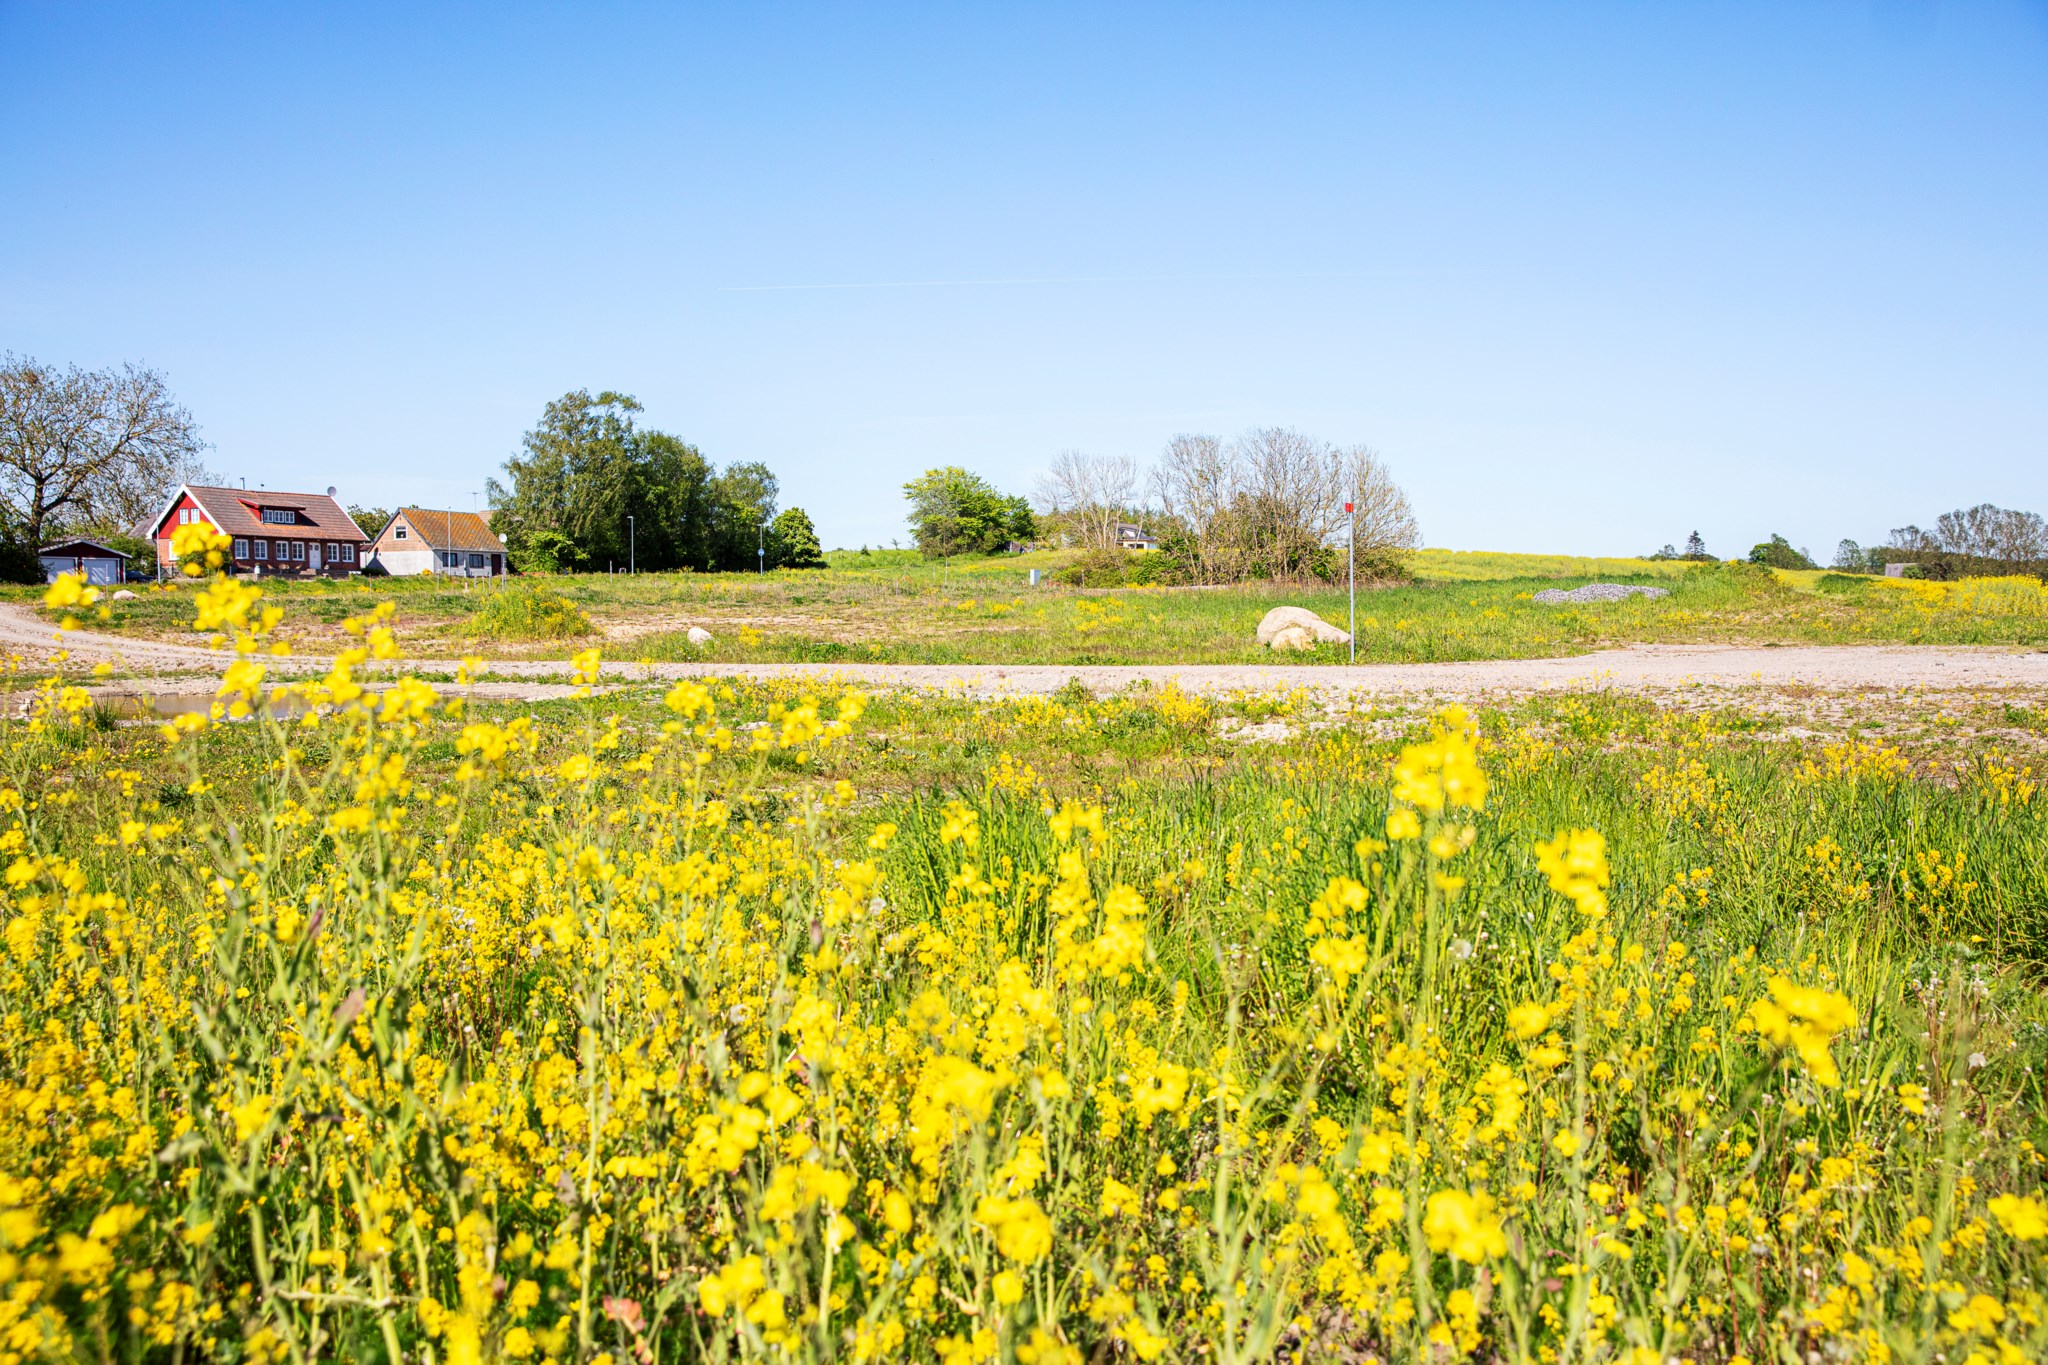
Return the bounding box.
[16,551,2048,665]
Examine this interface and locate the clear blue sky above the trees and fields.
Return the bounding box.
[0,0,2048,555]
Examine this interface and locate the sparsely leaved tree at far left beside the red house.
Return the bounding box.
[0,354,207,544]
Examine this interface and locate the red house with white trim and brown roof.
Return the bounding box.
[145,483,369,579]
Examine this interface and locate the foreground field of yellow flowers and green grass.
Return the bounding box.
[12,540,2048,1365]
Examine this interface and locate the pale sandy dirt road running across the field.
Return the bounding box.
[0,604,2048,700]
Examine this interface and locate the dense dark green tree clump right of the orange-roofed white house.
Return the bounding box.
[485,389,825,573]
